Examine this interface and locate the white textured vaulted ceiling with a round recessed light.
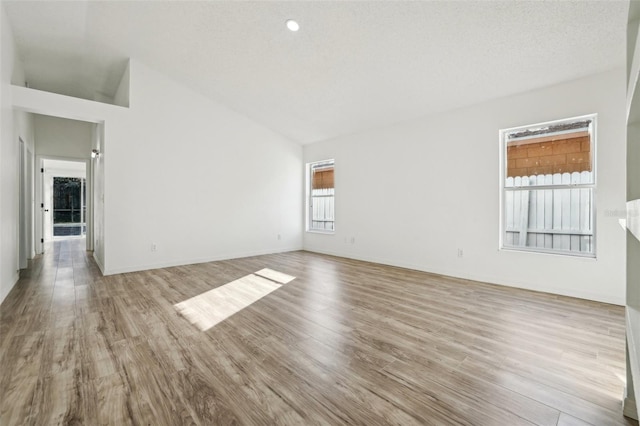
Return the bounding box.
[3,0,629,144]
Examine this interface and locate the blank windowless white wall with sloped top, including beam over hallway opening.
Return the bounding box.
[12,60,303,274]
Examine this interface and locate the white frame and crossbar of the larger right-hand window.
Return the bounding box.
[498,113,598,260]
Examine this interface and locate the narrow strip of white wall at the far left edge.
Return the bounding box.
[0,7,33,303]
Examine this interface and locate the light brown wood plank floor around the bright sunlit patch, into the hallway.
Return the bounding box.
[0,240,637,426]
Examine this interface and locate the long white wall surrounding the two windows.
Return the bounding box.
[304,68,625,304]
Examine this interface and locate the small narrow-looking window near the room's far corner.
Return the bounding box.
[307,160,335,232]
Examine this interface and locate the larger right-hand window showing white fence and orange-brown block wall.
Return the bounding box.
[500,115,596,257]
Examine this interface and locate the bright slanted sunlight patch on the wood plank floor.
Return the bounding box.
[174,268,295,331]
